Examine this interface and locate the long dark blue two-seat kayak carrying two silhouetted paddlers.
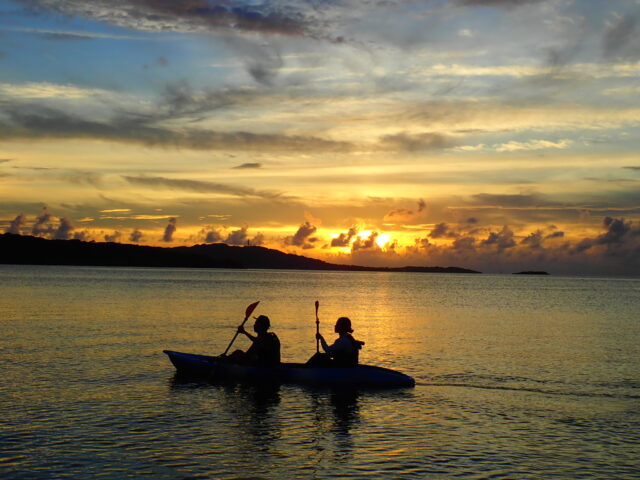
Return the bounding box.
[164,350,416,388]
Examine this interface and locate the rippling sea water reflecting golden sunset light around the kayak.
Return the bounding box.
[0,265,640,479]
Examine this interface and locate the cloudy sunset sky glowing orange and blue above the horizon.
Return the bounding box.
[0,0,640,275]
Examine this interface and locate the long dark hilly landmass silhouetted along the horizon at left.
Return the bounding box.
[0,233,480,273]
